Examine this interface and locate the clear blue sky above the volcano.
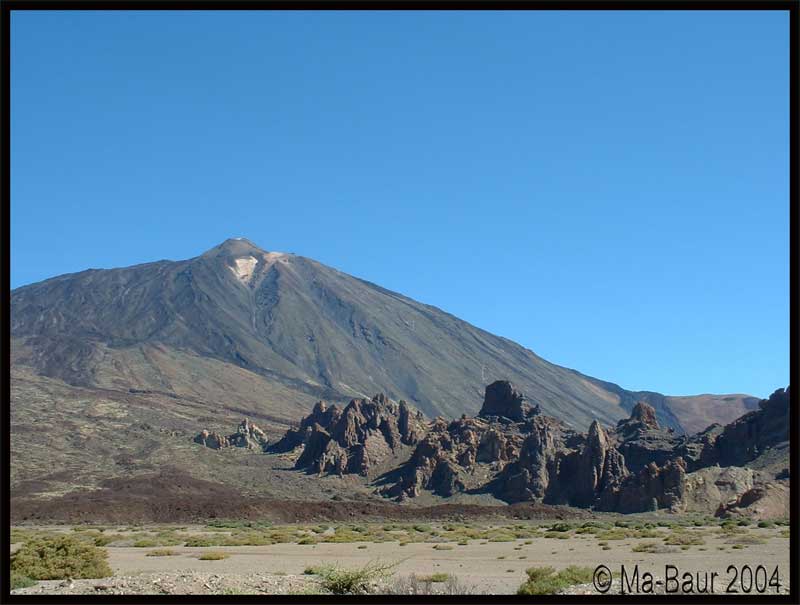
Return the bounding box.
[11,11,789,396]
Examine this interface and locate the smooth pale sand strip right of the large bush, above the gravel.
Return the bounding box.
[12,529,789,594]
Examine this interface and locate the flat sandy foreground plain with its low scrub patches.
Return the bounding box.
[12,520,790,595]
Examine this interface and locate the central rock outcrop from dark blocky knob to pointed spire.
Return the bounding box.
[382,382,628,506]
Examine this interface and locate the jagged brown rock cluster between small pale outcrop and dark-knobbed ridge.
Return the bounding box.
[270,393,425,476]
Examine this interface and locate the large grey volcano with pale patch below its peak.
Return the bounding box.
[11,239,757,431]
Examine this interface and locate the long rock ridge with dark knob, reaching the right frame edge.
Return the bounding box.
[380,382,788,513]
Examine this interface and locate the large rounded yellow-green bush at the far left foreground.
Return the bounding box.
[11,535,113,580]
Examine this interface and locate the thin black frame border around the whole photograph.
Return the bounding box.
[0,0,800,605]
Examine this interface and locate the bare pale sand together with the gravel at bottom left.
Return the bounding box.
[10,528,789,594]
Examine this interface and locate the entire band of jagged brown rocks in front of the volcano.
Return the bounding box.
[247,381,790,518]
